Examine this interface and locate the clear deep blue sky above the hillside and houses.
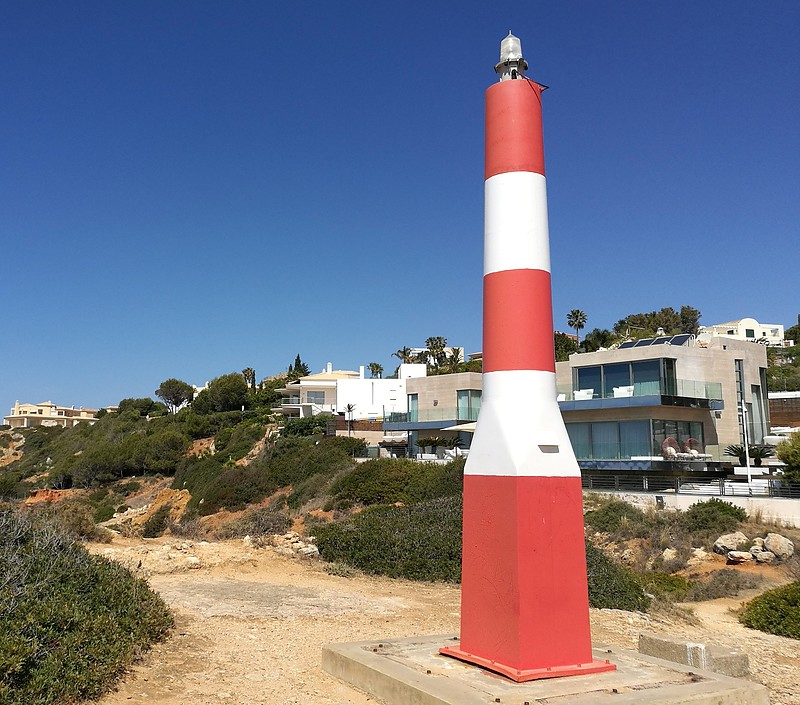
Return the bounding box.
[0,0,800,408]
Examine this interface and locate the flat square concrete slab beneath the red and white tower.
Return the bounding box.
[322,635,769,705]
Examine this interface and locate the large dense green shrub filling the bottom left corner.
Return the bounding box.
[0,511,172,705]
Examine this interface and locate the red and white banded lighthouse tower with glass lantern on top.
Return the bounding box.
[441,33,615,681]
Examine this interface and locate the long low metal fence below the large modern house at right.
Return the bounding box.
[581,473,800,499]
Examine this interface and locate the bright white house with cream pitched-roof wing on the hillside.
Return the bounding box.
[273,362,427,421]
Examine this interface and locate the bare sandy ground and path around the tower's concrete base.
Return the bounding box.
[91,539,800,705]
